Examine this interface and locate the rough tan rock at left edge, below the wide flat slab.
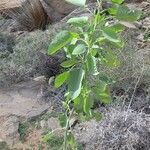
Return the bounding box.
[0,116,19,146]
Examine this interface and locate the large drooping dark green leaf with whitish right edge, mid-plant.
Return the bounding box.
[68,68,85,99]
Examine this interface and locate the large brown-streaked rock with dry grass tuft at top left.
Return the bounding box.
[0,0,96,31]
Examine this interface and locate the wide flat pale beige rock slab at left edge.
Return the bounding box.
[0,81,50,119]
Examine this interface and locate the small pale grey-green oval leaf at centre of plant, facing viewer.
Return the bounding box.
[72,44,86,55]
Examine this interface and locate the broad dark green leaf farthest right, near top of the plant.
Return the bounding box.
[116,6,141,22]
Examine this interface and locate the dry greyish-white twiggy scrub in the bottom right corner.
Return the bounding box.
[75,107,150,150]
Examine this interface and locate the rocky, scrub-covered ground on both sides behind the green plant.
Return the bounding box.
[0,2,150,150]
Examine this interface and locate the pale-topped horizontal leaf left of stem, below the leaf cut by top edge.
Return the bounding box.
[67,17,88,27]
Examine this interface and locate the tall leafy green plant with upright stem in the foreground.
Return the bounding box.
[48,0,141,150]
